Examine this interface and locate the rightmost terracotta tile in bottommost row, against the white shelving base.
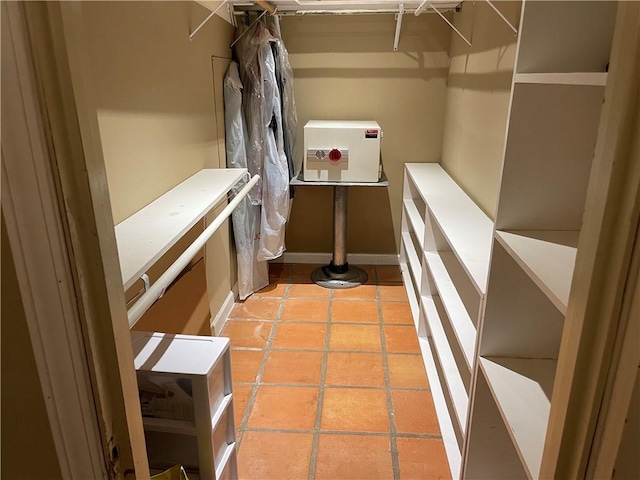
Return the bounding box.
[396,438,451,480]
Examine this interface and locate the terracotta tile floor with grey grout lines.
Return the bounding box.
[221,264,450,480]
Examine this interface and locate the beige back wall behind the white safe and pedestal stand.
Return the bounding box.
[281,15,450,254]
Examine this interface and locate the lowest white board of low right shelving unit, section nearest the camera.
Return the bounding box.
[418,337,462,480]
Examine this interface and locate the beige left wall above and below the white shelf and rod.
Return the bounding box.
[83,1,235,333]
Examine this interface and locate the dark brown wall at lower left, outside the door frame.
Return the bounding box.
[0,215,62,480]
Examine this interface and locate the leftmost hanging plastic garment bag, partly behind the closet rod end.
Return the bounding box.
[224,62,269,300]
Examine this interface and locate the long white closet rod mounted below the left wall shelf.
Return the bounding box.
[127,175,260,327]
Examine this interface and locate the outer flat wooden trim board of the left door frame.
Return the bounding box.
[2,2,107,478]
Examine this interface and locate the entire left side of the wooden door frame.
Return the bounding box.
[1,2,149,478]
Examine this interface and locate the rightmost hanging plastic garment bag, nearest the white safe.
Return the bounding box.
[269,16,302,184]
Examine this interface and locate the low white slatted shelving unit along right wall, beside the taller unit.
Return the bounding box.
[400,163,493,478]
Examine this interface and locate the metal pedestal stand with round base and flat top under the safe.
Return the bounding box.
[291,172,389,289]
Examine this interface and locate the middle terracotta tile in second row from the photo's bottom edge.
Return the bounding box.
[320,388,389,432]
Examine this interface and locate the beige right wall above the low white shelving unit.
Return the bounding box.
[441,2,520,218]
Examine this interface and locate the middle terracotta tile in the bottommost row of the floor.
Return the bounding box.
[315,434,396,480]
